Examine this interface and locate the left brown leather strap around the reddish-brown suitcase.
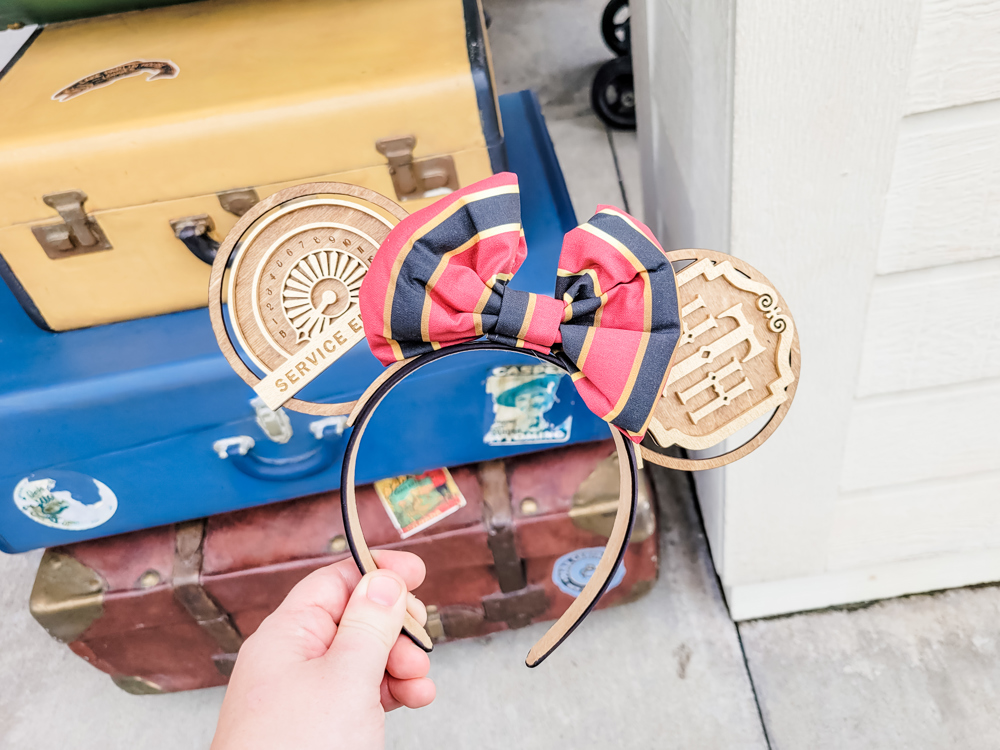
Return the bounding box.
[173,520,243,654]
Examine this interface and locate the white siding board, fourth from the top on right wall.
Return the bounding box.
[840,379,1000,491]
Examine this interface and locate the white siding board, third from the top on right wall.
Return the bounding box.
[858,258,1000,396]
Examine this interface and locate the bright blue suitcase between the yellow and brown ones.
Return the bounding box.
[0,92,608,552]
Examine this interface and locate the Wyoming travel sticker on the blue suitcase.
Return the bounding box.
[483,364,573,445]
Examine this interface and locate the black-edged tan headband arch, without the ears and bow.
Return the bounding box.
[340,341,638,667]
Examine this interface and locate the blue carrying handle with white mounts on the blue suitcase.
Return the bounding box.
[212,416,347,482]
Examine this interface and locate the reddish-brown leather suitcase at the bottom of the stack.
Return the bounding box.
[31,440,658,693]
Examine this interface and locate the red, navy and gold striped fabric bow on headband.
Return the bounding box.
[360,172,680,442]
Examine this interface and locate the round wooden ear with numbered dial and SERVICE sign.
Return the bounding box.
[209,182,408,415]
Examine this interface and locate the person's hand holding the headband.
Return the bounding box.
[212,551,435,750]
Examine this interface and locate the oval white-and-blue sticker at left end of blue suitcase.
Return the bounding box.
[14,471,118,531]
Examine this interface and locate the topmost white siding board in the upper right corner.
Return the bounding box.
[906,0,1000,114]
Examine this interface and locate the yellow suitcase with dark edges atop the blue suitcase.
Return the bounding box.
[0,0,504,331]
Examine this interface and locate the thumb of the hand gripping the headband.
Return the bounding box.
[326,570,406,690]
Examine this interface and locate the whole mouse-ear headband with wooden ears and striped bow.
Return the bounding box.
[209,173,799,666]
